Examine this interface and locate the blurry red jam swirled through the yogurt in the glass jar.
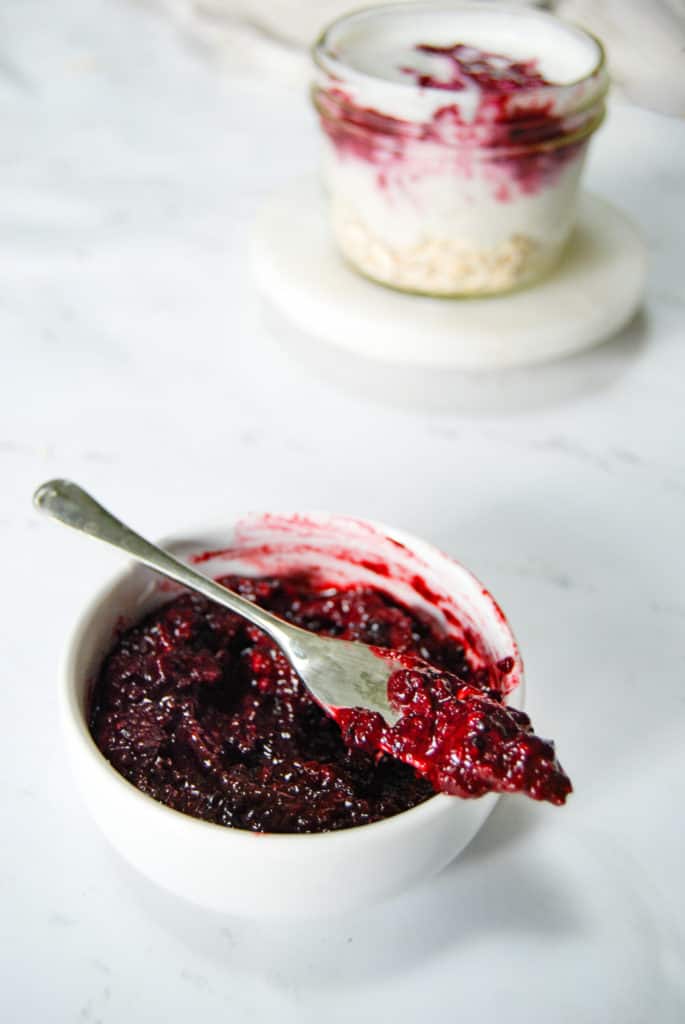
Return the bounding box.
[317,43,585,197]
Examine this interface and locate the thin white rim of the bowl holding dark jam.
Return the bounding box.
[59,509,526,846]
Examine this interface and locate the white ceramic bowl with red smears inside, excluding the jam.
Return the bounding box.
[61,514,522,916]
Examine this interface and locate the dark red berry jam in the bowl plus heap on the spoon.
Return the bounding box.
[91,574,570,833]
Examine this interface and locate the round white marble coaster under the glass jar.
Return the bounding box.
[250,176,646,370]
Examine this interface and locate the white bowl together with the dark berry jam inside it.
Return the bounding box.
[62,514,562,916]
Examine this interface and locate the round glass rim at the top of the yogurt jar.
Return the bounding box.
[310,0,608,96]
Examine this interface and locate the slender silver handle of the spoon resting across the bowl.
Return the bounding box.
[34,480,299,644]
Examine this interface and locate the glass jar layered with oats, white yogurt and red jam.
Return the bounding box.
[312,2,608,296]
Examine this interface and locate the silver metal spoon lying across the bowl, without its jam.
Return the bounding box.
[34,480,403,725]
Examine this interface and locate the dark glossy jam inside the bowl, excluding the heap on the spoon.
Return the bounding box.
[91,578,454,833]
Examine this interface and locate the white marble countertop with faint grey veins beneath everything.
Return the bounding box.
[0,0,685,1024]
